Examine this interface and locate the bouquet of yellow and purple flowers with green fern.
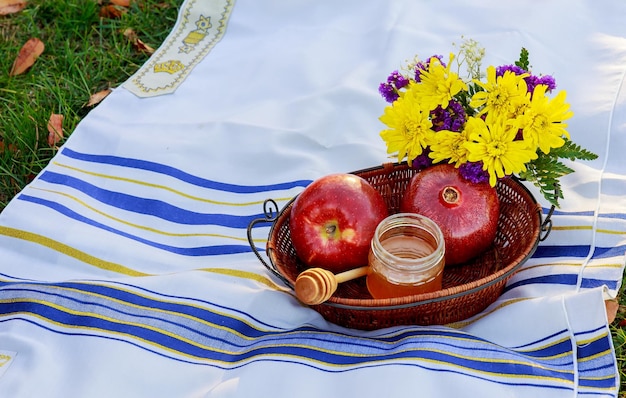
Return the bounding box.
[379,40,597,207]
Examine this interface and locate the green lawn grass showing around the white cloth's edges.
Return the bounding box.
[0,0,626,398]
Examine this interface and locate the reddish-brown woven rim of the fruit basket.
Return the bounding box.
[267,163,542,311]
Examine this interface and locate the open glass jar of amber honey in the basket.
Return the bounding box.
[366,213,445,299]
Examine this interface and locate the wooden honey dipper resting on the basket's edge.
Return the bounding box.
[295,265,369,305]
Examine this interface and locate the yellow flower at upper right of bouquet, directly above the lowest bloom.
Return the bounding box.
[470,66,530,120]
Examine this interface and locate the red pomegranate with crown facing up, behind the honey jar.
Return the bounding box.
[400,164,500,265]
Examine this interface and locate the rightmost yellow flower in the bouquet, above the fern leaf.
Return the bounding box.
[516,84,573,153]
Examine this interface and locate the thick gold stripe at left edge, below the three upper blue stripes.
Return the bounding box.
[0,226,151,276]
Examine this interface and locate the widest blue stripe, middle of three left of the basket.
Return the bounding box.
[33,171,263,228]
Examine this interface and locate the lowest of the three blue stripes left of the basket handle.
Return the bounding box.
[18,194,252,256]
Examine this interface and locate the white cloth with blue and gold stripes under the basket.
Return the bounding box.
[0,0,626,398]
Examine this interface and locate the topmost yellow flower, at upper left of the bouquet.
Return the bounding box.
[410,54,467,110]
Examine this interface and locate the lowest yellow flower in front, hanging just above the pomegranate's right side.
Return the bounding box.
[465,117,537,187]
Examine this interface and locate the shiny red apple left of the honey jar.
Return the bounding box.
[289,174,388,273]
